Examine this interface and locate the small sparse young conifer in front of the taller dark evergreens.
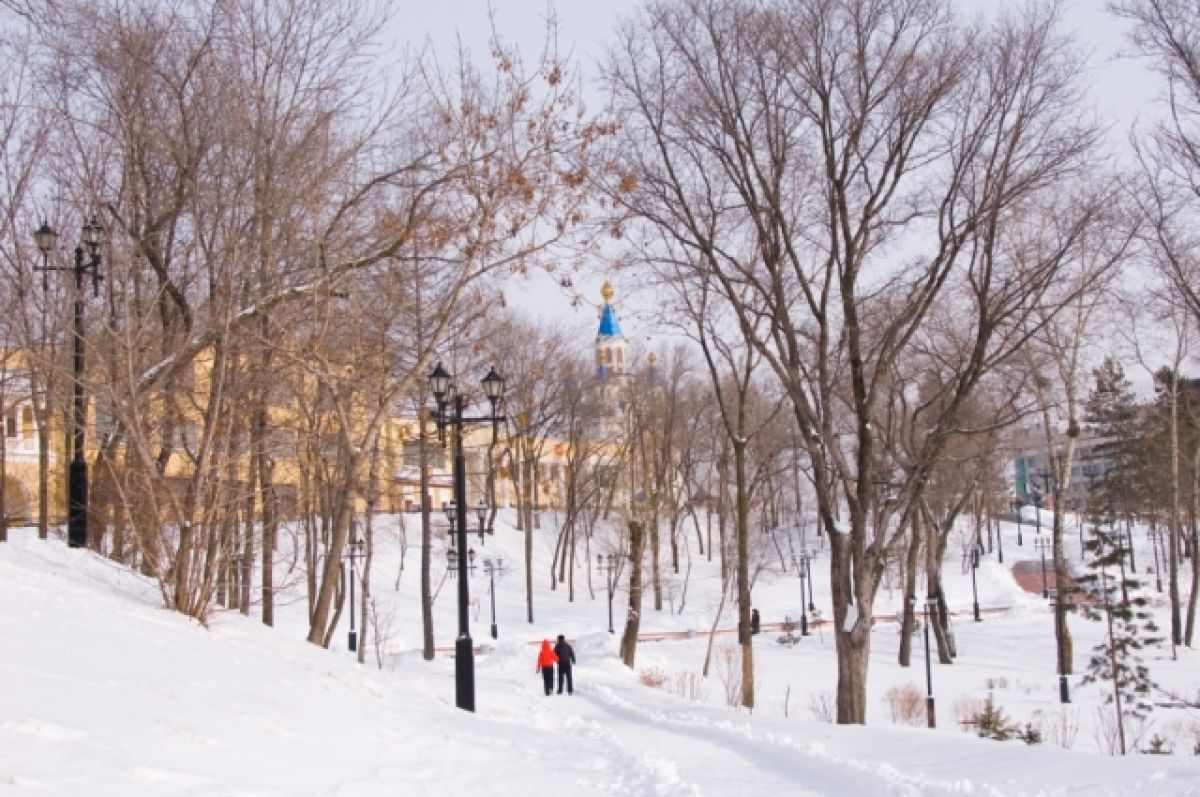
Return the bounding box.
[1079,508,1162,755]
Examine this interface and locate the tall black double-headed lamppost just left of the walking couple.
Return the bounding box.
[430,362,504,712]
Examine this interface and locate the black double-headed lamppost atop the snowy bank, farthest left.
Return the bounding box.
[34,217,104,547]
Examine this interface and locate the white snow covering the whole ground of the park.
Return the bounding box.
[0,506,1200,797]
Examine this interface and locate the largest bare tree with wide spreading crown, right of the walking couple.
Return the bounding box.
[607,0,1099,723]
